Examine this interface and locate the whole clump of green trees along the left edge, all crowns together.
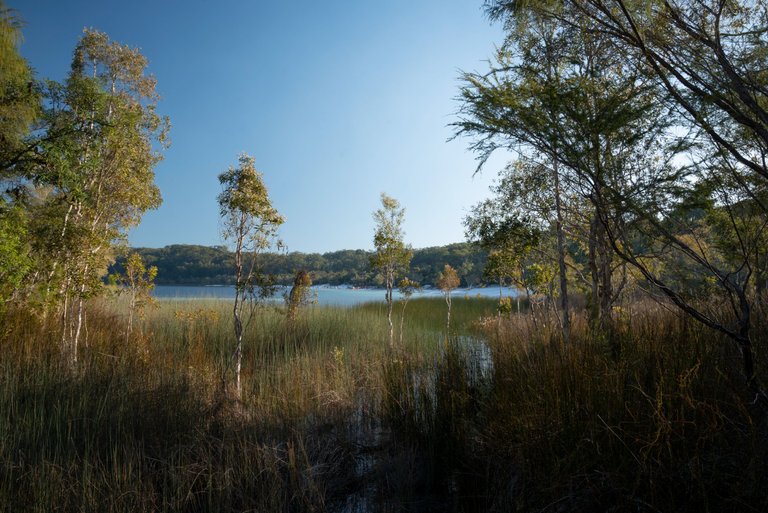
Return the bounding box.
[0,26,168,364]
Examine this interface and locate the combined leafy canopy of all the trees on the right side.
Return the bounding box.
[474,0,768,392]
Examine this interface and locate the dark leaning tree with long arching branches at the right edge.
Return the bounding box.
[480,0,768,398]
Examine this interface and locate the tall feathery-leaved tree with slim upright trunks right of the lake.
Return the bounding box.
[456,2,681,344]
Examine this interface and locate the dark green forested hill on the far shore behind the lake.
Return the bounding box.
[110,243,486,286]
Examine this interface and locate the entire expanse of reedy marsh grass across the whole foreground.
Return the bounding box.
[0,297,768,512]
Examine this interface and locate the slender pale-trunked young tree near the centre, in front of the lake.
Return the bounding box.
[371,192,413,347]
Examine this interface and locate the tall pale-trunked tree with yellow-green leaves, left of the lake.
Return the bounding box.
[27,30,169,364]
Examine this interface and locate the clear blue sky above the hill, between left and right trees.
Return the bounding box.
[6,0,504,252]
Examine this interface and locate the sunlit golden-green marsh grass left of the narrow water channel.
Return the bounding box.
[0,300,460,512]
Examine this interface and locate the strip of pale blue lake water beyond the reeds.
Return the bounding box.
[154,285,517,306]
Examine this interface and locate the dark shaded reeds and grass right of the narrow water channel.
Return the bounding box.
[388,304,768,512]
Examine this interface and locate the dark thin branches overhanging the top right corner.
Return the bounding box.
[528,0,768,197]
